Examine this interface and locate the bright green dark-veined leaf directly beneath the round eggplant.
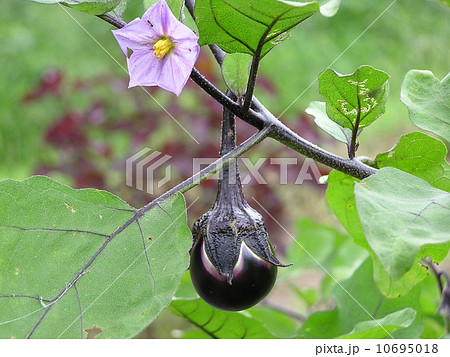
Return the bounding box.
[169,299,275,338]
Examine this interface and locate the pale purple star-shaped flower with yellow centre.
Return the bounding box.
[113,0,200,96]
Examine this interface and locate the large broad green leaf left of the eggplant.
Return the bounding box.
[0,176,192,338]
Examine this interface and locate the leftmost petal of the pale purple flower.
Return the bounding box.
[112,18,158,56]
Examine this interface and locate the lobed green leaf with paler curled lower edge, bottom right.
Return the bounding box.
[299,259,422,338]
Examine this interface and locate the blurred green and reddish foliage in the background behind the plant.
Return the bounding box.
[0,0,450,337]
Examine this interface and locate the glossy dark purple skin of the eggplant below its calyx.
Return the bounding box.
[190,239,277,311]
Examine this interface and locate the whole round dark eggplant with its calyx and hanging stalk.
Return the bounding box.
[190,96,285,311]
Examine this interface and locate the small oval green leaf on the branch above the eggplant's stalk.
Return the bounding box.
[222,53,252,97]
